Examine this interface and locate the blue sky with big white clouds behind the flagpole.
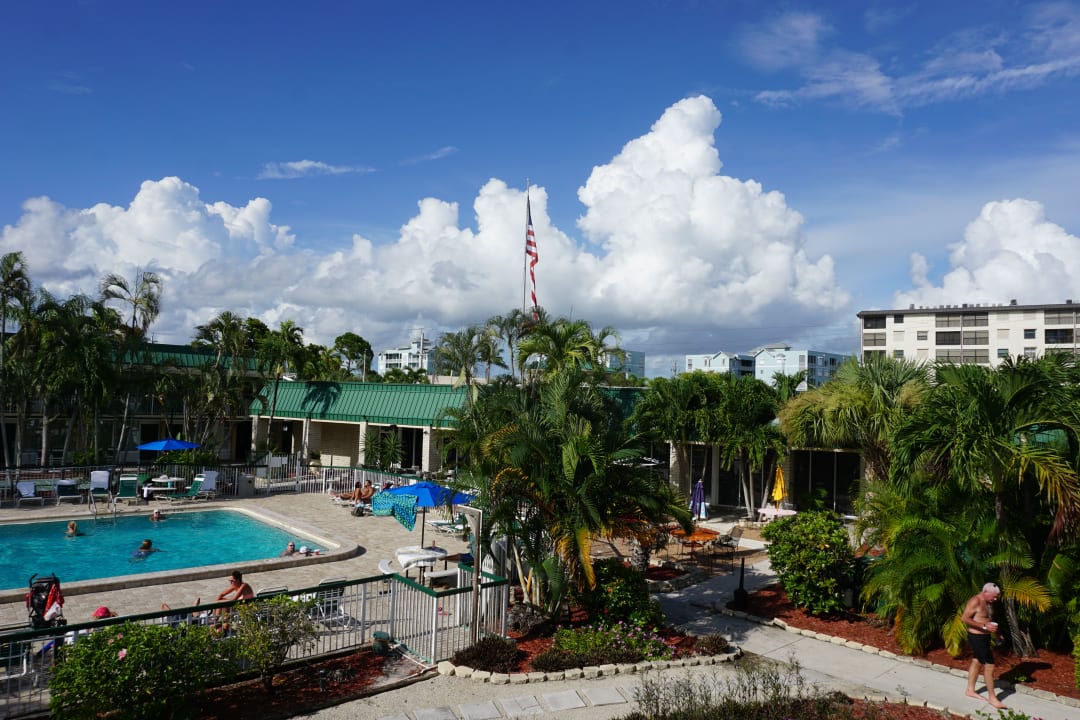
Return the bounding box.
[0,0,1080,375]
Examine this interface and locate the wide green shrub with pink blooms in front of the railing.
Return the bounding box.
[49,623,239,720]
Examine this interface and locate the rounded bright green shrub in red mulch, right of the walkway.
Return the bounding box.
[761,512,854,615]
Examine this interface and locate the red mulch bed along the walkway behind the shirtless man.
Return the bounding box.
[746,585,1080,699]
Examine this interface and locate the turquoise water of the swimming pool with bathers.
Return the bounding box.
[0,510,311,589]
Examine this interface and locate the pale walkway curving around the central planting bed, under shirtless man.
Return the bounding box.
[317,524,1080,720]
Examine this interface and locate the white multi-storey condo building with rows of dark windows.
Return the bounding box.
[858,300,1080,367]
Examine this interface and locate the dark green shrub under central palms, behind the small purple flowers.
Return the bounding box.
[572,558,664,627]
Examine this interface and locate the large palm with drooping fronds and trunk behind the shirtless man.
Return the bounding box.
[891,355,1080,657]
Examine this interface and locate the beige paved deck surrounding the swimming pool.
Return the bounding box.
[0,493,469,627]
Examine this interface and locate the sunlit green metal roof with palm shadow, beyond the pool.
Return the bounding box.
[251,381,465,427]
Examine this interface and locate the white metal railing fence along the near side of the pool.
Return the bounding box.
[0,563,510,718]
